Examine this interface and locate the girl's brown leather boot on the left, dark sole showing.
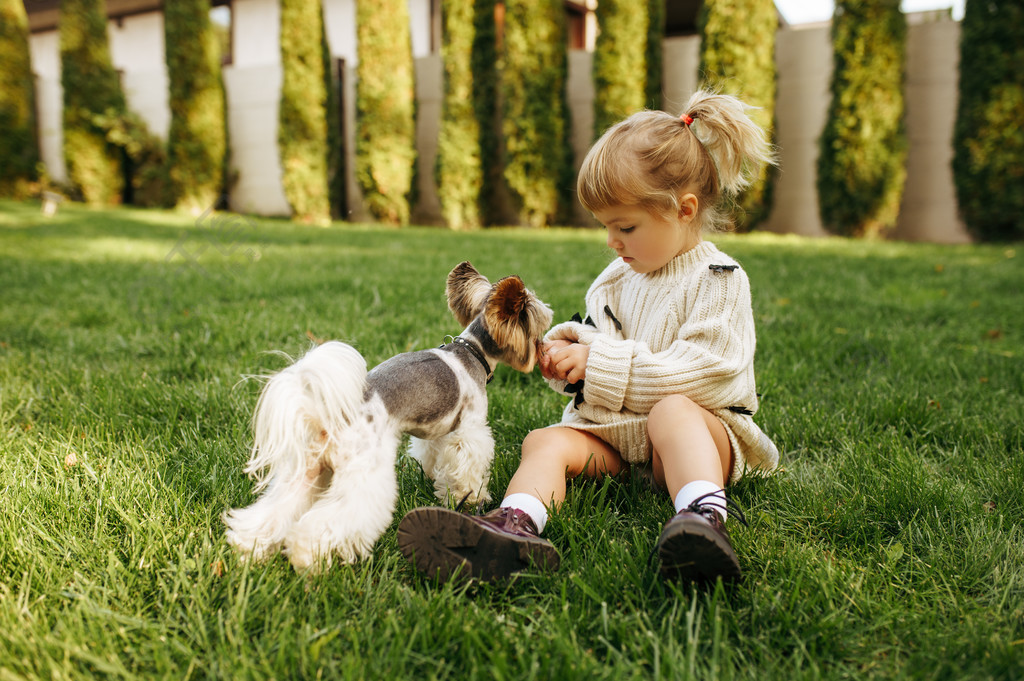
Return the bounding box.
[397,507,559,582]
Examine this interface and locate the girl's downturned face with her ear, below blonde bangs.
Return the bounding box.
[594,194,700,274]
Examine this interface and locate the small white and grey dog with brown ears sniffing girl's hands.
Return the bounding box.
[224,262,552,570]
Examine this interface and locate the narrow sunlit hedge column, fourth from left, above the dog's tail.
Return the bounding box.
[278,0,327,224]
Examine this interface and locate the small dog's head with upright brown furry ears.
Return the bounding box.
[447,261,552,373]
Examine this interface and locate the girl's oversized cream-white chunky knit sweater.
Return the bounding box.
[547,242,778,481]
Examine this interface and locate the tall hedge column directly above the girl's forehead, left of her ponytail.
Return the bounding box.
[594,0,648,139]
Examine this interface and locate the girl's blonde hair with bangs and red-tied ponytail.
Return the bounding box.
[577,90,775,231]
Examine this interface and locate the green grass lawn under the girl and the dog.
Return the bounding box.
[0,202,1024,681]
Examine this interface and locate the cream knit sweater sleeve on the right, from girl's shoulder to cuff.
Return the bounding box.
[580,269,757,414]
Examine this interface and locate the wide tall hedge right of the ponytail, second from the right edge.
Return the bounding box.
[817,0,907,237]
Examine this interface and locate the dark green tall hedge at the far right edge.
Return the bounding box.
[953,0,1024,240]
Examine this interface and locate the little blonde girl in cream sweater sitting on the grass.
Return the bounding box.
[398,87,778,581]
